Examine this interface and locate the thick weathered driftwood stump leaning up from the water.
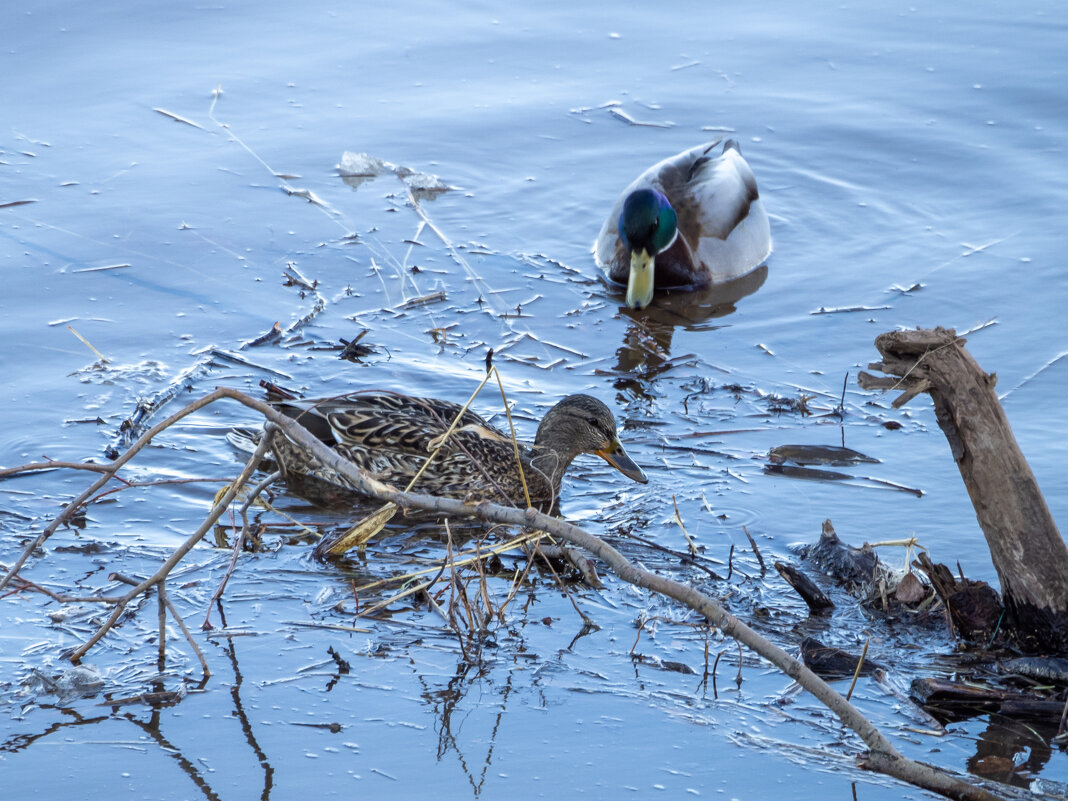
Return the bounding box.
[859,328,1068,654]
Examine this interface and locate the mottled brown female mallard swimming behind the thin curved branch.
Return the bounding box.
[262,392,648,508]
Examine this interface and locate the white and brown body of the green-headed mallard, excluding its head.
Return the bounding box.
[594,140,771,299]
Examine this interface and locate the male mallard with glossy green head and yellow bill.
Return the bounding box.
[594,139,771,309]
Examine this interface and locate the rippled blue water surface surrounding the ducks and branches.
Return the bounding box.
[0,2,1068,799]
